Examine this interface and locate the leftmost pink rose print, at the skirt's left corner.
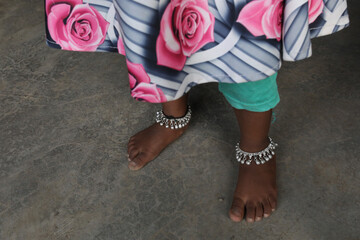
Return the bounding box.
[46,0,109,51]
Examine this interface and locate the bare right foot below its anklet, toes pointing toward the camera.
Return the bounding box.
[229,142,277,222]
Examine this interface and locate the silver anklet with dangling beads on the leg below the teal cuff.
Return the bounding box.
[235,137,278,165]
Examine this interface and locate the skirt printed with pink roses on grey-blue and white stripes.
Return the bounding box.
[45,0,349,103]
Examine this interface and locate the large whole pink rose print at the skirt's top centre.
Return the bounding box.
[156,0,215,71]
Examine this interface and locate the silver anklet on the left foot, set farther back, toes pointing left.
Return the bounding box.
[156,105,191,129]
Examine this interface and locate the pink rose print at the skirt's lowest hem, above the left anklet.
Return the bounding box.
[126,60,167,103]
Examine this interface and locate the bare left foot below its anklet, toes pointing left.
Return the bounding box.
[128,116,189,170]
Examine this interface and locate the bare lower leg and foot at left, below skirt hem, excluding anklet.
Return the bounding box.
[128,93,190,170]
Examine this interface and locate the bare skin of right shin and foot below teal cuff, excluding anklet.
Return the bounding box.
[229,108,277,222]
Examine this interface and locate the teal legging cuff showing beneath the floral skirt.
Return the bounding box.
[218,73,280,112]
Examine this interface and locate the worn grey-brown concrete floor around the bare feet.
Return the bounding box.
[0,0,360,240]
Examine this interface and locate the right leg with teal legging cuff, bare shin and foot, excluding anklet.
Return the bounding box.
[219,74,280,222]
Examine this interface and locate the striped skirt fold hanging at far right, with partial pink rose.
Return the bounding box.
[282,0,349,61]
